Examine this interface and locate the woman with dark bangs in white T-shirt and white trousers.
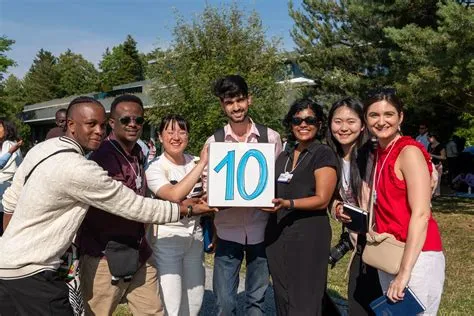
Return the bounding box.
[146,115,208,315]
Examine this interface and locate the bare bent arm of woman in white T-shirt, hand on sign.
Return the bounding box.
[154,145,208,203]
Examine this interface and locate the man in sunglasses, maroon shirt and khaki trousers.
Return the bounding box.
[77,95,162,315]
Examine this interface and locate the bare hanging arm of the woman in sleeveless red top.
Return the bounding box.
[387,146,431,301]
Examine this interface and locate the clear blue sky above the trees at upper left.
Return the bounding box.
[0,0,299,78]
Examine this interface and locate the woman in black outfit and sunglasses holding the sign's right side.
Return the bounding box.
[265,99,337,315]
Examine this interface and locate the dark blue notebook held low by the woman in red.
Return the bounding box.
[370,287,426,316]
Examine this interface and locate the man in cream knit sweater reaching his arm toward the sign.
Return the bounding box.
[0,97,211,315]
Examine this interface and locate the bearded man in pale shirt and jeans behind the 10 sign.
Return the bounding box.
[203,75,282,315]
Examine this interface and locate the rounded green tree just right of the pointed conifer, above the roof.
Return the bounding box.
[56,49,99,96]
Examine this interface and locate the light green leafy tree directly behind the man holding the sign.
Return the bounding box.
[148,5,284,153]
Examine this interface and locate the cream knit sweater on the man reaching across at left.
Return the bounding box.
[0,137,180,279]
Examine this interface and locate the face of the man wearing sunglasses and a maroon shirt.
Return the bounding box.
[109,102,144,145]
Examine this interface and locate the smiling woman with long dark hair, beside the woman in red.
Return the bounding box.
[326,97,382,316]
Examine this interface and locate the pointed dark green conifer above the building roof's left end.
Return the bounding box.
[23,49,62,104]
